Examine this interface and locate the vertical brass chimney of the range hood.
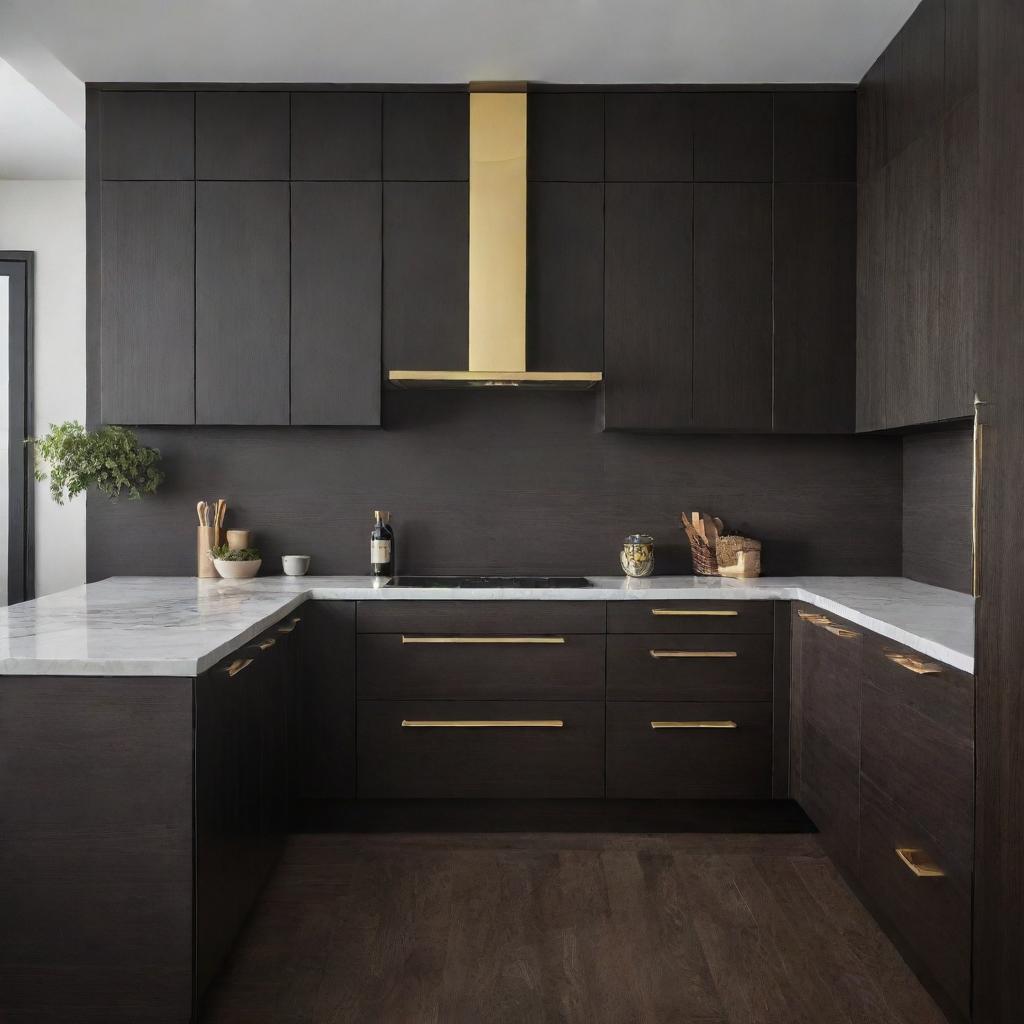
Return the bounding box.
[469,92,526,373]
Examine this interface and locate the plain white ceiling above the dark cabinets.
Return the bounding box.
[0,0,918,176]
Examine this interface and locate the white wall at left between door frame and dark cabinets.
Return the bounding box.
[0,180,85,596]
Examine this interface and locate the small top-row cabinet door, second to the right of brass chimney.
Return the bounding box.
[604,92,693,181]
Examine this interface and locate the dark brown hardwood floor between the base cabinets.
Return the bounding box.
[203,834,944,1024]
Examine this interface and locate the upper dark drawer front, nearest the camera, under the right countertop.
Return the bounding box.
[860,640,974,873]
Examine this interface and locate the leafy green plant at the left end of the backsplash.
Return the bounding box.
[26,420,164,505]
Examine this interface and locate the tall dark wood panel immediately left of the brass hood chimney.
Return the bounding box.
[383,181,469,370]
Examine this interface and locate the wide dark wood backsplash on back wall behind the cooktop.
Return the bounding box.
[88,390,900,581]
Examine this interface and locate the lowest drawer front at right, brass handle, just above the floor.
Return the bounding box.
[860,780,971,1016]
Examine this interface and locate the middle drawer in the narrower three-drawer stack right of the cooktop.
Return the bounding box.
[608,634,772,700]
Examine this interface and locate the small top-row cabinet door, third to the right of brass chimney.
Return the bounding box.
[693,92,772,181]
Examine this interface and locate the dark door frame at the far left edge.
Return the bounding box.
[0,250,36,604]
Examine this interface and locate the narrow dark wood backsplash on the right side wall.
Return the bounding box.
[903,424,973,593]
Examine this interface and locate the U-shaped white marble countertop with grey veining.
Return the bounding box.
[0,577,974,676]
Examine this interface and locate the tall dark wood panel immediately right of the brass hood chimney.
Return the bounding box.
[526,181,604,371]
